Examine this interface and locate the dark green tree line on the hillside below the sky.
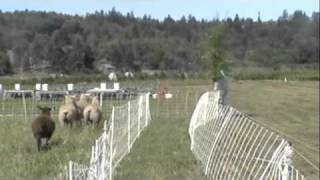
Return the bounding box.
[0,9,319,75]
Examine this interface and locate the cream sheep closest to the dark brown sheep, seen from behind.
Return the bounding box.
[58,96,81,127]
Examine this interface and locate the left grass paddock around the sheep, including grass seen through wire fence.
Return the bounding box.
[0,99,124,180]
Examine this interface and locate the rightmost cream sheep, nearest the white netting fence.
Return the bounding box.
[83,96,102,127]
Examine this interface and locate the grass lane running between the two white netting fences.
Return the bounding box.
[115,91,205,180]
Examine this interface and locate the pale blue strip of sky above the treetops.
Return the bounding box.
[0,0,319,21]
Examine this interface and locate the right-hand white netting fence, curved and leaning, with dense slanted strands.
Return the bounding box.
[189,91,304,180]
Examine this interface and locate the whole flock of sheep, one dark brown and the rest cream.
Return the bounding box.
[31,94,102,151]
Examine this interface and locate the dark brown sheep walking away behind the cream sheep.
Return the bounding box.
[31,106,55,152]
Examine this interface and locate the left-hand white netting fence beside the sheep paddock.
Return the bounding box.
[56,93,151,180]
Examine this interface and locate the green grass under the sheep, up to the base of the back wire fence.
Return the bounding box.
[0,119,100,180]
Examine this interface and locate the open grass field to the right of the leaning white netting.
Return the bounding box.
[231,81,319,179]
